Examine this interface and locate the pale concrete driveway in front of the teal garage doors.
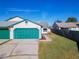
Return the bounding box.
[0,40,39,59]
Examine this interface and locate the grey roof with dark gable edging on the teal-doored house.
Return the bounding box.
[0,16,42,28]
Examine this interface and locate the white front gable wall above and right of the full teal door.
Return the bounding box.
[14,21,42,39]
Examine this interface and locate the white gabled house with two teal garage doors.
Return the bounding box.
[0,17,42,39]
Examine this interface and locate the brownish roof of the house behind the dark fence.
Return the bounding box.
[56,22,79,28]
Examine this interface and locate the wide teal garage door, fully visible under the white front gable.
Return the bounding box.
[14,28,39,39]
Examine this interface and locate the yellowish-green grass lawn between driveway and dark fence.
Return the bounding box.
[39,33,79,59]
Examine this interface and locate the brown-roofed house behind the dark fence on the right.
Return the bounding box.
[53,22,79,31]
